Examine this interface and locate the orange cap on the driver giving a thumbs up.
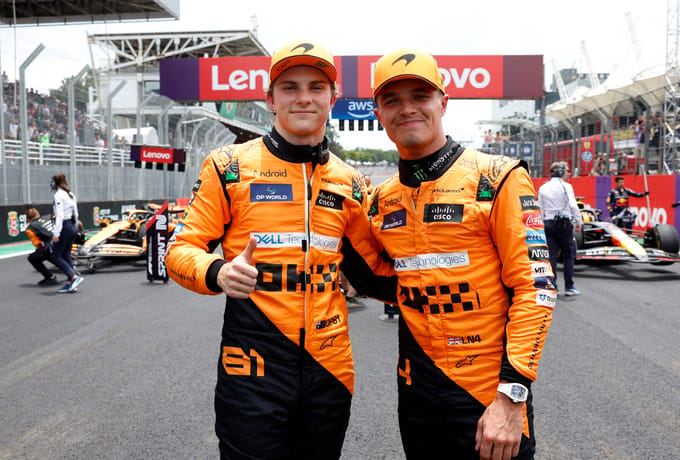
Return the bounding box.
[269,40,338,85]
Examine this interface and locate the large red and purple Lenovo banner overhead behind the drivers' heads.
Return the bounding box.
[160,55,543,101]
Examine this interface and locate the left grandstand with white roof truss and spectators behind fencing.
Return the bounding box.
[0,15,272,204]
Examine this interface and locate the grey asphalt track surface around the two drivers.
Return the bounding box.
[0,252,680,460]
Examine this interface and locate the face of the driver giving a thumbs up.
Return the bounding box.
[267,66,336,145]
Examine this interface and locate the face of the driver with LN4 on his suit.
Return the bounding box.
[374,80,449,159]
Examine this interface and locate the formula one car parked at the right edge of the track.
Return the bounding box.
[574,202,680,265]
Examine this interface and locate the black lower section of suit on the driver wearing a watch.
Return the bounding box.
[398,317,536,460]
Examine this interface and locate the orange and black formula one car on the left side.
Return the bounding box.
[71,203,185,273]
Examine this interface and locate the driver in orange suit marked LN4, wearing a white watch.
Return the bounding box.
[370,49,556,460]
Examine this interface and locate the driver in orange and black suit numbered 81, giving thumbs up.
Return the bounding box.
[166,41,396,459]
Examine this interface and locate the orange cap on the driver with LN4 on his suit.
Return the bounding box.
[373,49,446,99]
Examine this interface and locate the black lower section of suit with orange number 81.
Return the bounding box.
[215,299,352,460]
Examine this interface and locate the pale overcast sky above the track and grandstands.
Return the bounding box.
[0,0,677,149]
